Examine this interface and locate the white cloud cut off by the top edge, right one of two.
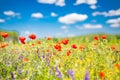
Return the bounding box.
[74,0,97,9]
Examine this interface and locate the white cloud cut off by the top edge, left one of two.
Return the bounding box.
[38,0,65,6]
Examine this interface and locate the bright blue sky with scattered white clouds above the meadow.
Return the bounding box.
[0,0,120,37]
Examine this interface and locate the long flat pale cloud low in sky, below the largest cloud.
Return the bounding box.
[76,24,103,30]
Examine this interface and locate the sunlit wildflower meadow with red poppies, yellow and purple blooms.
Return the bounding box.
[0,32,120,80]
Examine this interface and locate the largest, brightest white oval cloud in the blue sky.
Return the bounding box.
[58,13,88,24]
